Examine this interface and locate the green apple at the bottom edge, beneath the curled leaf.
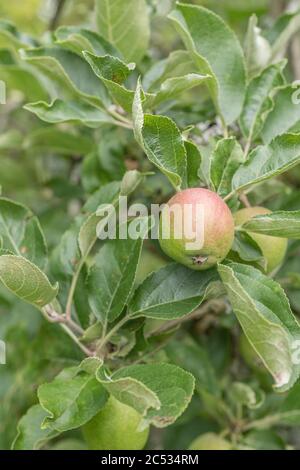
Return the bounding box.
[82,396,149,450]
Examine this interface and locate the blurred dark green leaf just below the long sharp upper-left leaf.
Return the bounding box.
[23,126,94,156]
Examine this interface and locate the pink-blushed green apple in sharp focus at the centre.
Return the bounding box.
[159,188,234,271]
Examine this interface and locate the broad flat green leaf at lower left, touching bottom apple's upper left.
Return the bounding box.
[38,365,108,432]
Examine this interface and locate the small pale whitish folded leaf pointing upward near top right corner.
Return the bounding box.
[244,15,272,77]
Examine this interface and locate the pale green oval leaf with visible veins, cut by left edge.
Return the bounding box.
[0,255,58,308]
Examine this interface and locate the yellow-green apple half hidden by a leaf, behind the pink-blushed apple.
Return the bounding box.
[234,206,288,274]
